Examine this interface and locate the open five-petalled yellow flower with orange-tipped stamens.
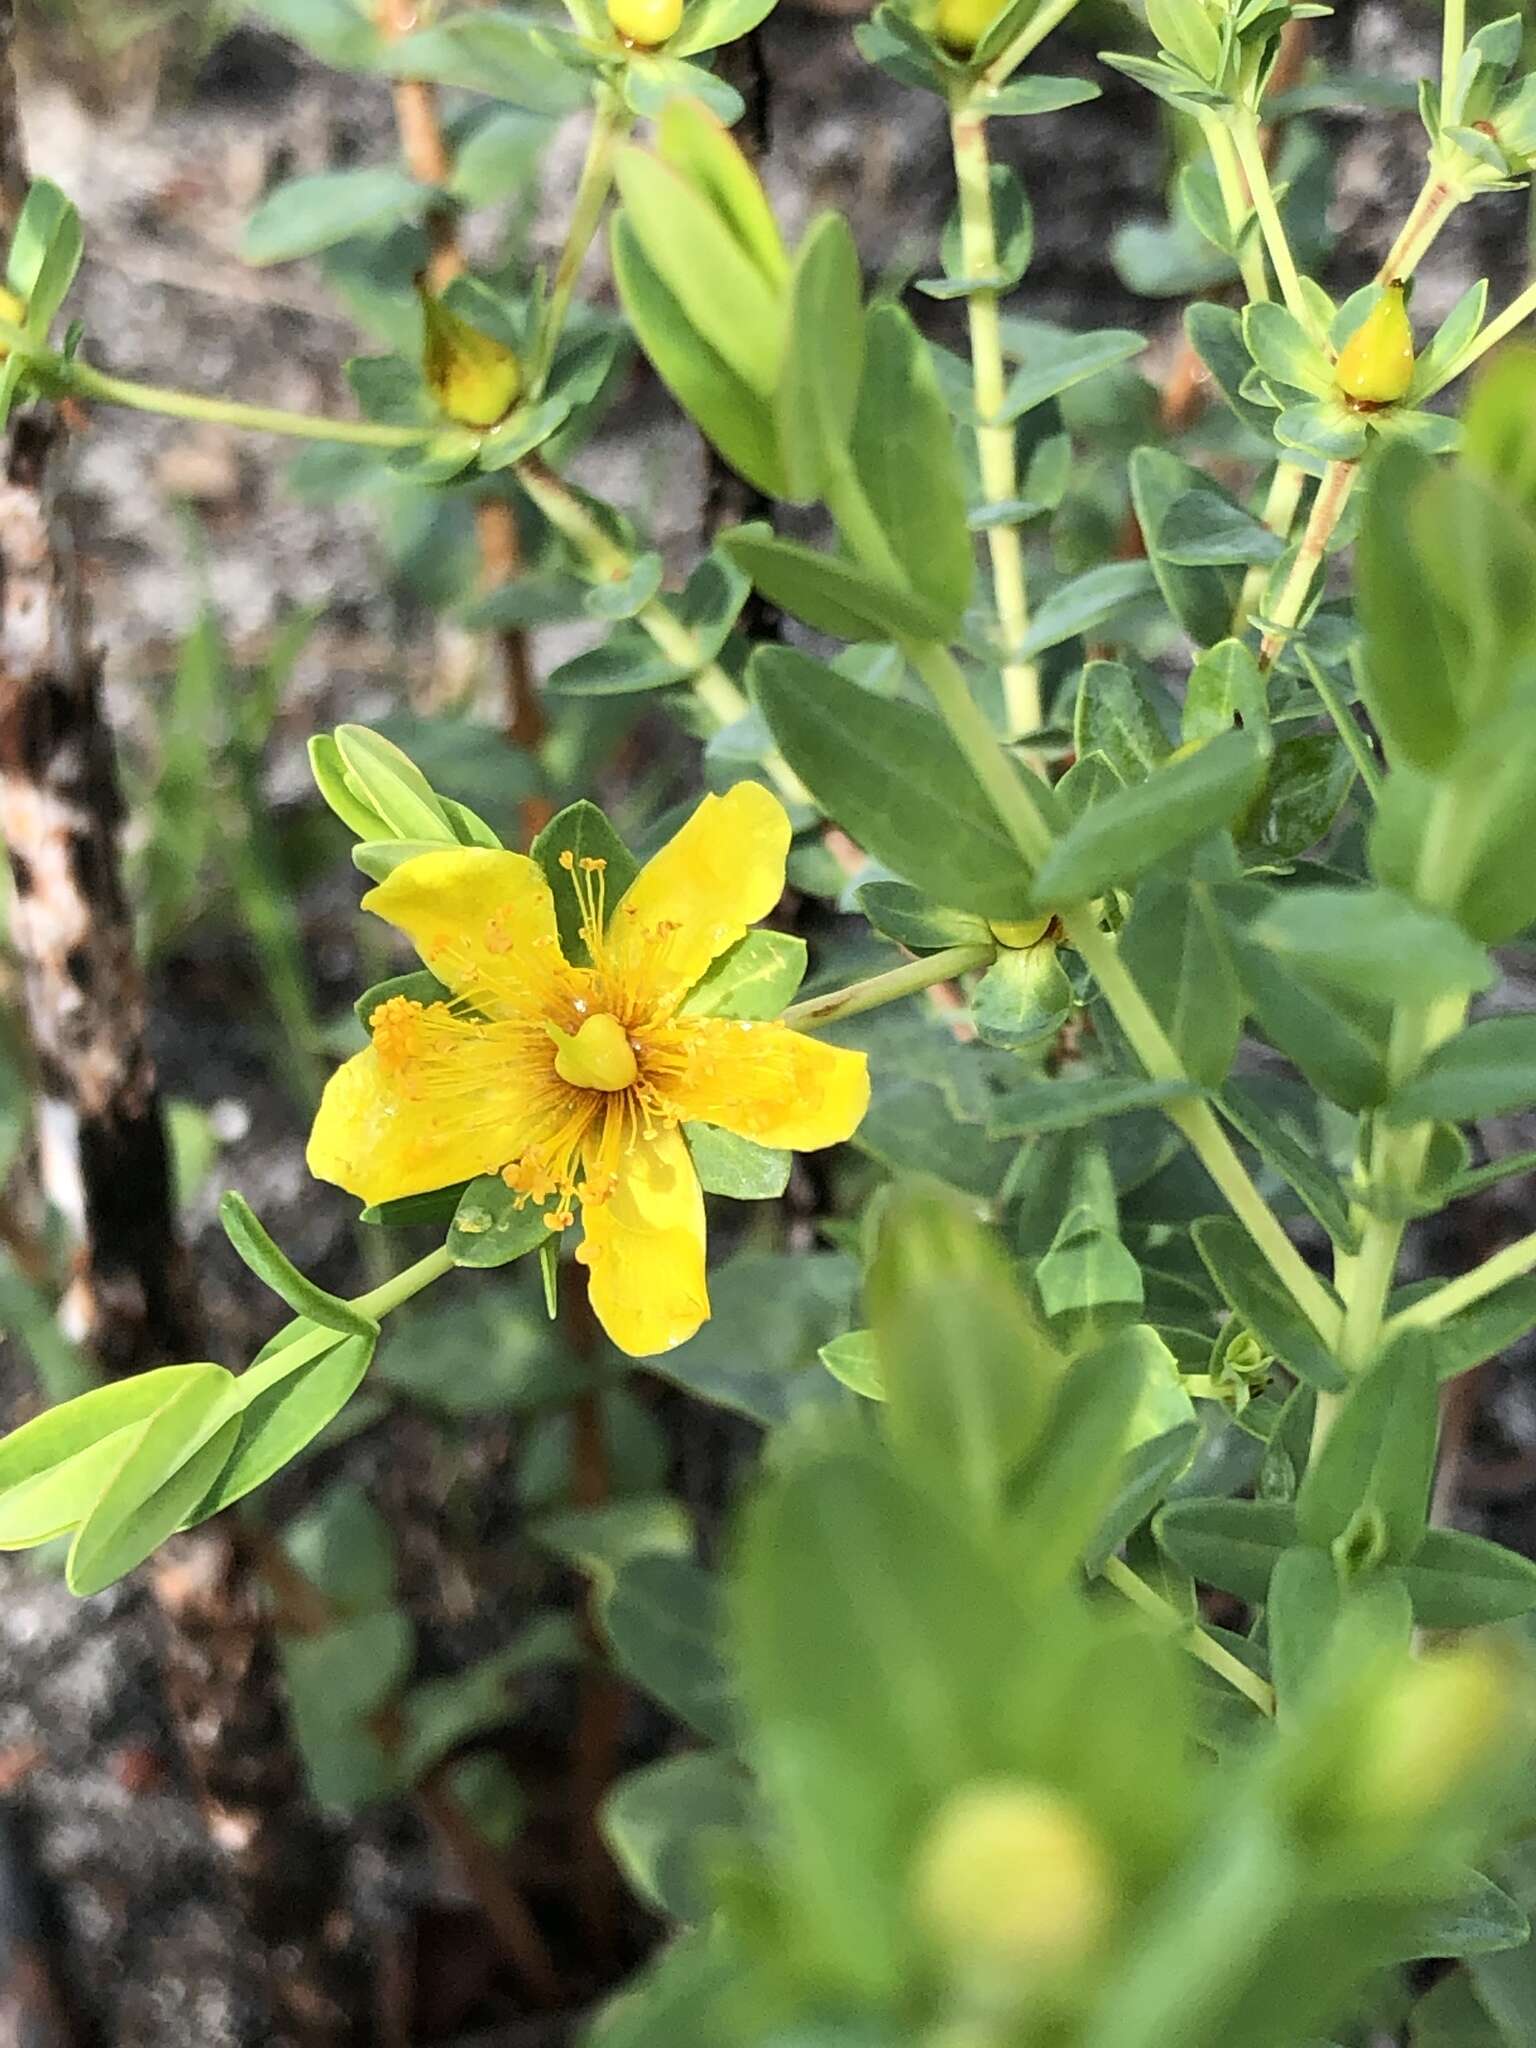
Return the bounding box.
[309,782,868,1358]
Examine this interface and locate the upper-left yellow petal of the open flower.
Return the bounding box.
[362,846,561,1016]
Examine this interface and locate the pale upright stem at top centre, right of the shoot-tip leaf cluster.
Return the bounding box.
[950,98,1040,739]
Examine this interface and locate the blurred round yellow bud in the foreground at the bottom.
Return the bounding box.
[913,1778,1114,1982]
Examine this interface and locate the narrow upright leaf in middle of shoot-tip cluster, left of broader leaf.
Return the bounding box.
[774,213,864,504]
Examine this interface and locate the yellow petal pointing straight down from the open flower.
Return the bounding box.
[575,1130,709,1358]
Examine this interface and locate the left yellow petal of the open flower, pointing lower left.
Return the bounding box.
[305,1034,528,1202]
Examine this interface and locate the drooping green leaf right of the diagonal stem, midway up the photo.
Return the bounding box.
[1120,874,1243,1087]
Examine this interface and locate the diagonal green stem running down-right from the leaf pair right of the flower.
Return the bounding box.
[1063,909,1339,1343]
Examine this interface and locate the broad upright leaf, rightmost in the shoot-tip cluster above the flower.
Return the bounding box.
[847,303,975,639]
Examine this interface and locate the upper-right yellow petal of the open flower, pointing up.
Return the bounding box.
[608,782,791,993]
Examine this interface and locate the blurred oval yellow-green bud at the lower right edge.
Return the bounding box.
[1348,1647,1518,1823]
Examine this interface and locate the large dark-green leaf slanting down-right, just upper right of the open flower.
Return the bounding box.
[748,647,1030,918]
